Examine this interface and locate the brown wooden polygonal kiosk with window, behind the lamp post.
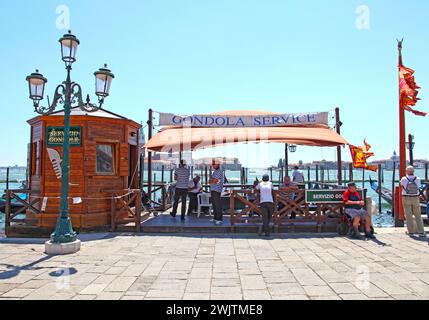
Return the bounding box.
[26,108,141,230]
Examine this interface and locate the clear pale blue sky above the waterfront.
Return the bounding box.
[0,0,429,166]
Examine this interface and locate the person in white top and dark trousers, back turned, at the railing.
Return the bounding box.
[256,174,274,237]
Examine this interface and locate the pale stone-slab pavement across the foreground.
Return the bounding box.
[0,229,429,300]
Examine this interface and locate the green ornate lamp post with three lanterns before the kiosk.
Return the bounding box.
[26,31,114,254]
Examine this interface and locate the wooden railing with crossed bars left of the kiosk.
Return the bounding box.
[5,189,40,235]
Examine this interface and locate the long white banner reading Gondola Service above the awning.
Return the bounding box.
[159,112,329,128]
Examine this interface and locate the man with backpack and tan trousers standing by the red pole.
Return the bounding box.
[401,166,425,237]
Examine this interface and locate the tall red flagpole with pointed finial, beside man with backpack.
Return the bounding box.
[395,40,407,227]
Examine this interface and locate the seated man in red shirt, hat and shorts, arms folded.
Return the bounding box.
[343,182,375,239]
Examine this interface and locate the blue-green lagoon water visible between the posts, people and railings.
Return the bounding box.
[0,168,424,234]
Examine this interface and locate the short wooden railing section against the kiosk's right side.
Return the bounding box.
[105,189,142,232]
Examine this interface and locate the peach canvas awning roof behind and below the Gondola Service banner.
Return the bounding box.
[145,111,348,152]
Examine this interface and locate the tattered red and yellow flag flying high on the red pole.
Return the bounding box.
[399,63,426,117]
